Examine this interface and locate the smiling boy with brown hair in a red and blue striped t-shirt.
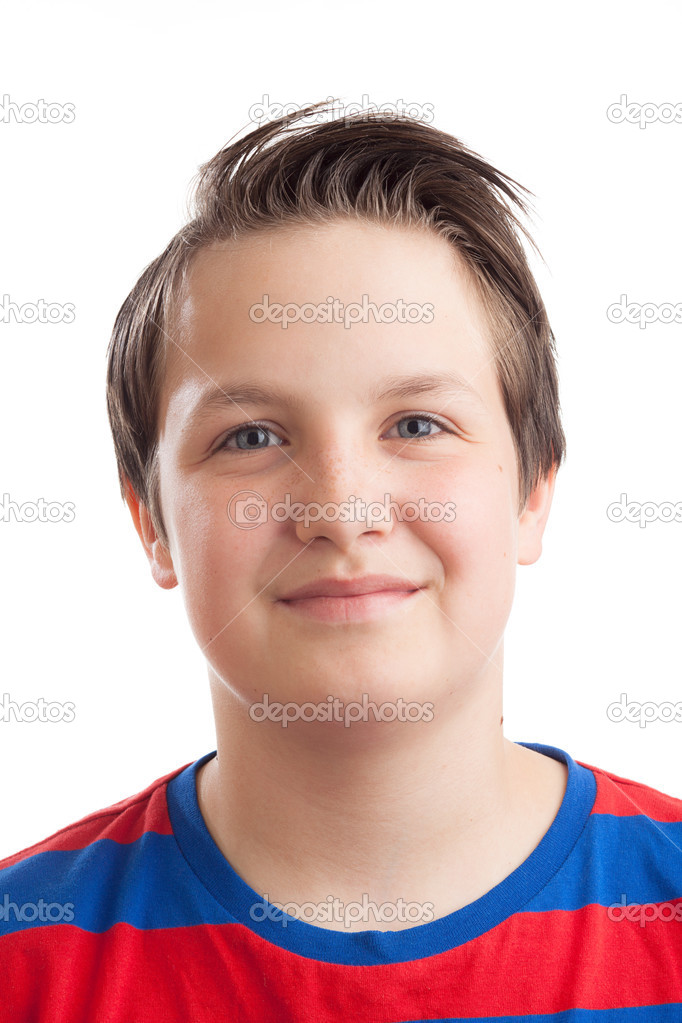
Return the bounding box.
[0,104,682,1023]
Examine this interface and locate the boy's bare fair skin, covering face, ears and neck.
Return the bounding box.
[128,221,565,930]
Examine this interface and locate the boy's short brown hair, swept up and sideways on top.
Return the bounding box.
[106,101,565,546]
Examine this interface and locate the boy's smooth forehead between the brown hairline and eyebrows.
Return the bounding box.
[161,220,498,421]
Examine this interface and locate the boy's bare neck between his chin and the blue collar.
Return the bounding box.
[197,666,566,930]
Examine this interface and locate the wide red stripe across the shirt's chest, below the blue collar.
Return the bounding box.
[0,905,682,1023]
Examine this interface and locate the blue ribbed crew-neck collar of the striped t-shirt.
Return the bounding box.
[167,743,596,966]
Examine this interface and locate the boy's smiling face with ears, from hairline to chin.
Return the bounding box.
[131,221,553,720]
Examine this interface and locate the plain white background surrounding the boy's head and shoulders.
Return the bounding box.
[0,0,682,856]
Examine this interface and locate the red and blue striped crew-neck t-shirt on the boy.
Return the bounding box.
[0,744,682,1023]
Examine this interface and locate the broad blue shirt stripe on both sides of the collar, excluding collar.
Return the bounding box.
[0,814,682,934]
